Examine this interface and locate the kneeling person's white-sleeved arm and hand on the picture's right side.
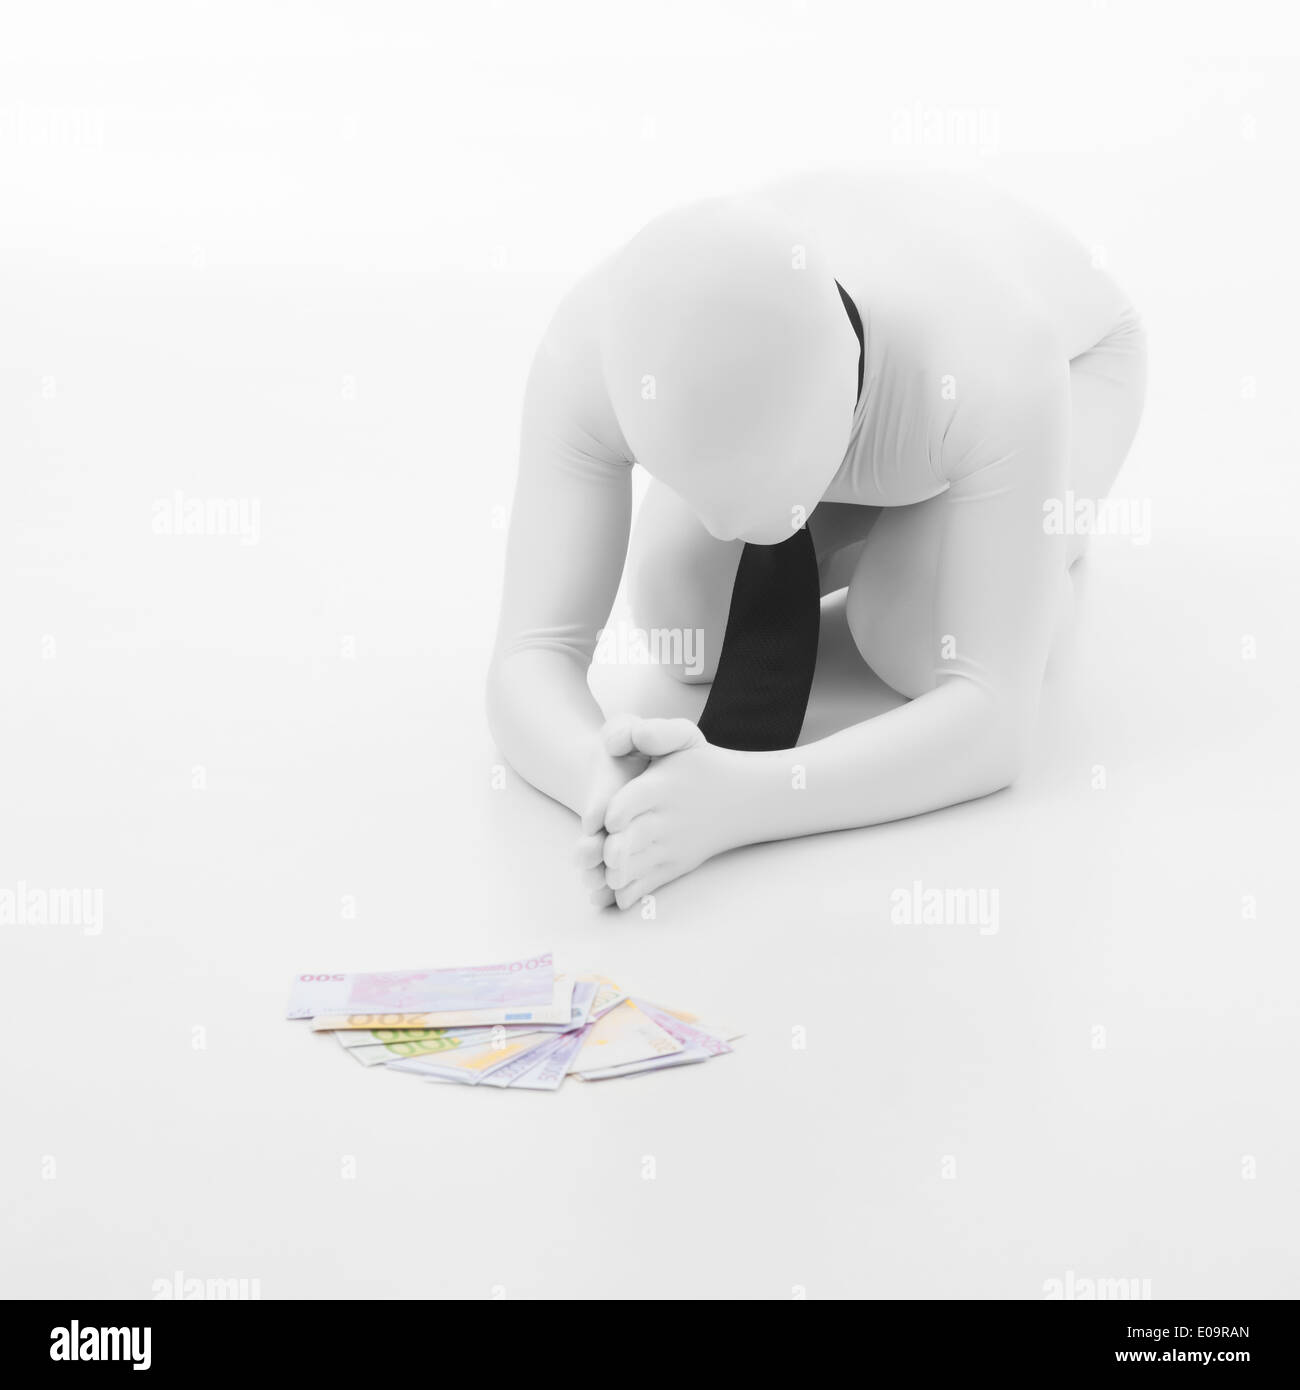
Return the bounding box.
[603,334,1069,908]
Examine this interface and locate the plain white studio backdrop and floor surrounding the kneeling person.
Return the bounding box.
[0,0,1300,1298]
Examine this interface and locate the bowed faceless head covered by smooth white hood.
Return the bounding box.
[601,197,859,545]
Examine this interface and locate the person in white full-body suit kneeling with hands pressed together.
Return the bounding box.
[488,174,1146,908]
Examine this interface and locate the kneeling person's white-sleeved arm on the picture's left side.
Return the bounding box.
[488,284,644,815]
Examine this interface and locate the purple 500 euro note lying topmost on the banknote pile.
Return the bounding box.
[286,951,550,1027]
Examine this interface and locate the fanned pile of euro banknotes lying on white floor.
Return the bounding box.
[288,952,738,1091]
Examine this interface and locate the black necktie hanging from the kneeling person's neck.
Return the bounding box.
[699,281,866,752]
